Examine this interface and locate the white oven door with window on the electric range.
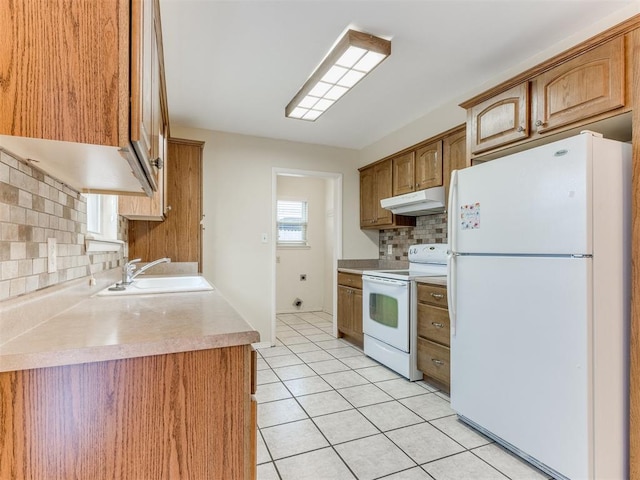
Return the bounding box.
[362,275,411,352]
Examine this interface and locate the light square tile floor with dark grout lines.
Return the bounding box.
[256,312,549,480]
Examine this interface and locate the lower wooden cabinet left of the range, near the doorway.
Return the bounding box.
[337,272,364,346]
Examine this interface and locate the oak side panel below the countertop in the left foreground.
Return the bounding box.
[0,345,252,480]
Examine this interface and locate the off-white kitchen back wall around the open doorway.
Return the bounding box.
[171,125,378,342]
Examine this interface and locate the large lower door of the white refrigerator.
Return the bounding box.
[451,256,592,479]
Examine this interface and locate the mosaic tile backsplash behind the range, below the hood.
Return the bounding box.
[378,213,447,261]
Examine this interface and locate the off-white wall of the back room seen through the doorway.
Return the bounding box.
[276,175,333,313]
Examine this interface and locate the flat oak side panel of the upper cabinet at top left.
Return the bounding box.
[0,0,129,146]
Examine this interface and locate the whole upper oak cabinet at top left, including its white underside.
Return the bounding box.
[0,0,168,195]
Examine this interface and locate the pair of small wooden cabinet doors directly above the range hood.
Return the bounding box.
[393,141,442,196]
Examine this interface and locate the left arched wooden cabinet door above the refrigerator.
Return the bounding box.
[467,82,530,153]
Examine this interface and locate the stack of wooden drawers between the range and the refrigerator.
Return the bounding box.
[417,283,451,392]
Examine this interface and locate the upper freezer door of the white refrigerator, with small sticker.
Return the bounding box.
[449,135,593,254]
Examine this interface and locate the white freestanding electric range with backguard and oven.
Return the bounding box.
[362,243,448,381]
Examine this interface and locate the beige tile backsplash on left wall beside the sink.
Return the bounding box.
[0,149,127,301]
